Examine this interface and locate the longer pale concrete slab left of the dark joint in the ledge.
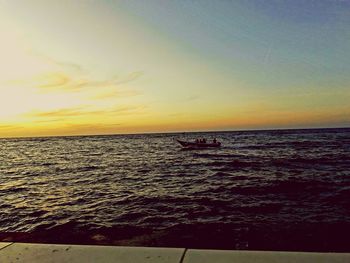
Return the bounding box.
[0,243,185,263]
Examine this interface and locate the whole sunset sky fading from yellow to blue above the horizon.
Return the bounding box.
[0,0,350,137]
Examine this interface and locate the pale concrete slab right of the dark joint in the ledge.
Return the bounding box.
[183,249,350,263]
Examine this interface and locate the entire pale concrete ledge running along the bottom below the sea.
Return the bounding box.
[0,242,350,263]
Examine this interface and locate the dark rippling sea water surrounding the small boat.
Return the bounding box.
[0,129,350,252]
